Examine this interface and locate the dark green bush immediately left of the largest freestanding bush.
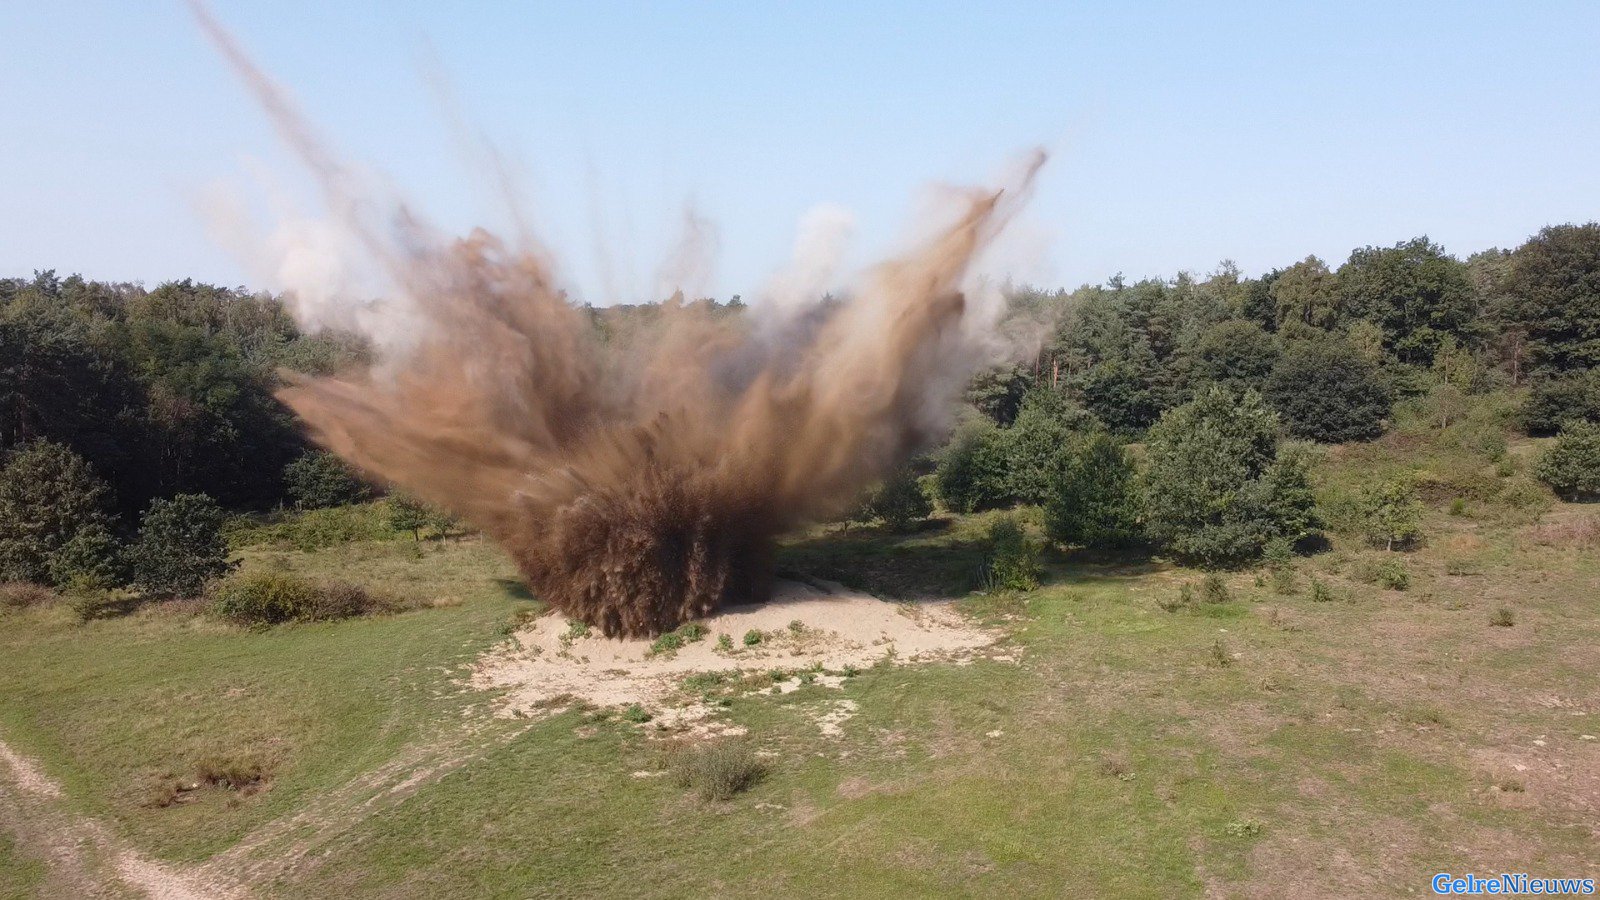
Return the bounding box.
[1045,432,1139,548]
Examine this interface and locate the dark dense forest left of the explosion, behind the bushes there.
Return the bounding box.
[0,272,363,517]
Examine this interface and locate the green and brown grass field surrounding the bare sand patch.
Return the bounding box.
[0,434,1600,897]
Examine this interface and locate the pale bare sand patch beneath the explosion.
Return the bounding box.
[472,581,995,723]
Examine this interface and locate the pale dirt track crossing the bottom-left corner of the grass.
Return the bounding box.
[0,741,245,900]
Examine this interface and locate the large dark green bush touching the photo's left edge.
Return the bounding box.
[0,440,115,585]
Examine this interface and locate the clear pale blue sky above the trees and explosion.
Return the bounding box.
[0,0,1600,303]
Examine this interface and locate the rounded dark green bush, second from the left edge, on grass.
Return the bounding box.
[128,493,232,599]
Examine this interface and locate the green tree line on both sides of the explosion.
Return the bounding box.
[0,223,1600,583]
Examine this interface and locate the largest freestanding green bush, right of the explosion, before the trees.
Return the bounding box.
[1142,386,1317,565]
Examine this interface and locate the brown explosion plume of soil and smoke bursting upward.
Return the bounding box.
[197,10,1043,637]
